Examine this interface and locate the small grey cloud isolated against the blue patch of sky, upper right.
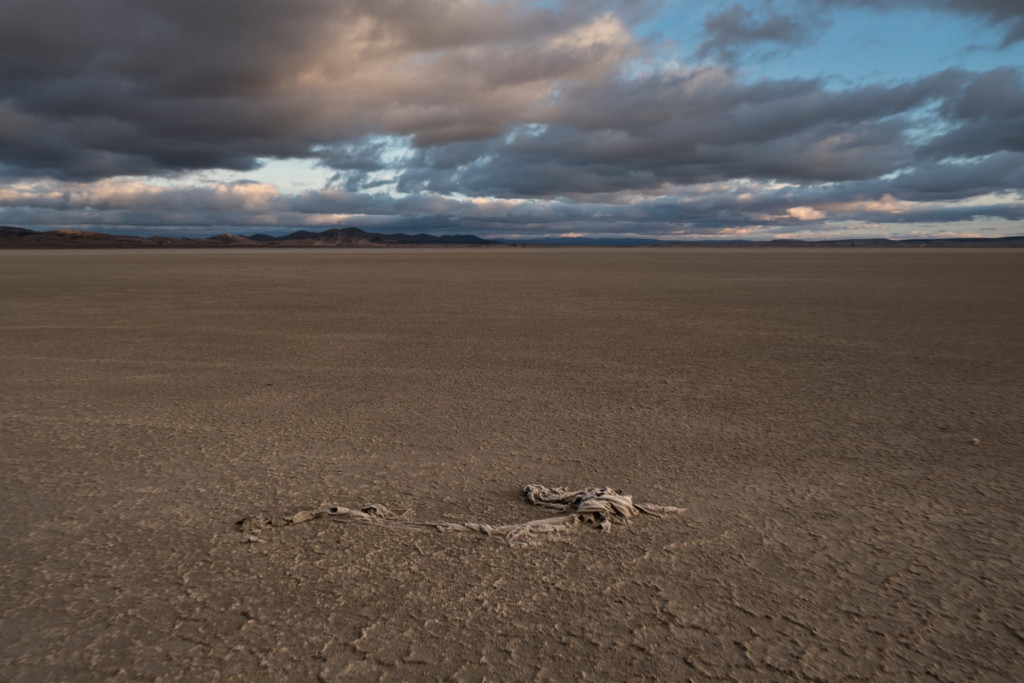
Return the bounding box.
[697,4,827,61]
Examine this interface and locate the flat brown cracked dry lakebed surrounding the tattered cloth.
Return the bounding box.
[0,249,1024,681]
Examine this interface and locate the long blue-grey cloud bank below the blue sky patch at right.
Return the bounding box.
[385,68,1007,198]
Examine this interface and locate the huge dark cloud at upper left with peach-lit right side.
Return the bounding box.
[0,0,634,178]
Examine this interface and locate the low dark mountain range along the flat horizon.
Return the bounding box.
[0,226,1024,249]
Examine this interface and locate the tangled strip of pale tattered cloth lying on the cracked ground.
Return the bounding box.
[238,484,683,546]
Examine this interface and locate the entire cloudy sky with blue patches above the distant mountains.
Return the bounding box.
[0,0,1024,241]
